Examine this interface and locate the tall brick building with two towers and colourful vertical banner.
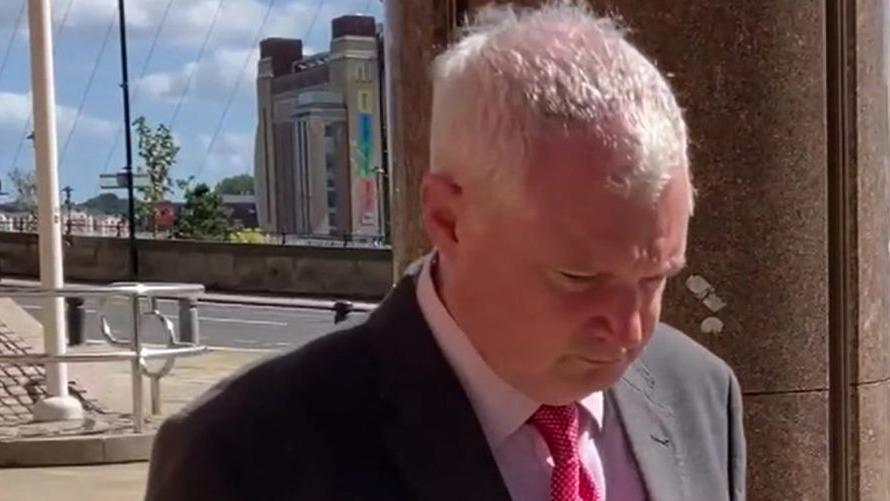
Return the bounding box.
[254,16,385,238]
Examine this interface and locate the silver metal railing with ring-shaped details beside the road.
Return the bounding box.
[0,282,208,433]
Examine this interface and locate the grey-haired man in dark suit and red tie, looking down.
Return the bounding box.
[147,2,745,501]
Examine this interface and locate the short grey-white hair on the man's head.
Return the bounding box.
[430,0,688,207]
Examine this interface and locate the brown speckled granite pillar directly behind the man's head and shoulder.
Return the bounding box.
[386,0,890,501]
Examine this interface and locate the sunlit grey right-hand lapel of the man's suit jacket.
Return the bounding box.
[610,360,686,501]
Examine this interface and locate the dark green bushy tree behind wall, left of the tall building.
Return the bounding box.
[173,181,229,240]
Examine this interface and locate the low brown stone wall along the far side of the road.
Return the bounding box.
[0,233,392,299]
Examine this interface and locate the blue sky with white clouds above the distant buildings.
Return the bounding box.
[0,0,383,201]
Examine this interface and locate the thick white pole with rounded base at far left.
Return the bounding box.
[28,0,83,421]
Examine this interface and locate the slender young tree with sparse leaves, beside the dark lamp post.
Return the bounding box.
[133,117,179,235]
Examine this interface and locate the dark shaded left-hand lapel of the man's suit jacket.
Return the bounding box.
[368,276,510,501]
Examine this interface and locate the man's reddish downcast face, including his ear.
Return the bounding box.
[430,132,690,405]
